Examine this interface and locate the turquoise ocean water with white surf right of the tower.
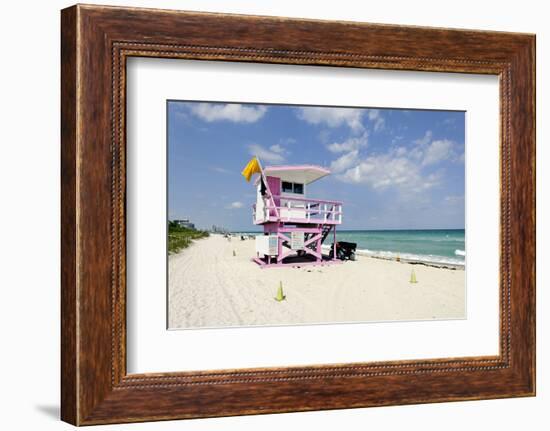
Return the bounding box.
[336,229,466,265]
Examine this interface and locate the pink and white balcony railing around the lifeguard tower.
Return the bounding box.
[252,195,342,225]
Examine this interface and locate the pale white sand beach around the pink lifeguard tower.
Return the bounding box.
[168,235,466,329]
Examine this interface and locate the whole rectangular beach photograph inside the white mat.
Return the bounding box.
[166,100,466,329]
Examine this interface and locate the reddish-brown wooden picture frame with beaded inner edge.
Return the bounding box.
[61,5,535,425]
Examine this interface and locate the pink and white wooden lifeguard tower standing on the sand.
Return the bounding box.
[252,165,342,268]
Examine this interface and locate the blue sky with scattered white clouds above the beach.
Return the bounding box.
[168,101,465,230]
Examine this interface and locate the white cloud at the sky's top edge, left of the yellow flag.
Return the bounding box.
[189,103,267,123]
